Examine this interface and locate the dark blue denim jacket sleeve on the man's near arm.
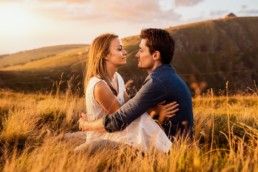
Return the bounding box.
[103,77,165,132]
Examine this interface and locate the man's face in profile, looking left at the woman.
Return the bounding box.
[136,39,154,73]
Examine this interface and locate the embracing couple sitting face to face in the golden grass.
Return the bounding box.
[74,28,193,152]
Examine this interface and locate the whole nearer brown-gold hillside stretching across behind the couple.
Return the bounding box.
[0,17,258,93]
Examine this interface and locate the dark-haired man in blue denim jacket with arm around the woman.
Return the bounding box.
[79,28,193,139]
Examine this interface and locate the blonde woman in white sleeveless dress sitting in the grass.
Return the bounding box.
[77,34,176,152]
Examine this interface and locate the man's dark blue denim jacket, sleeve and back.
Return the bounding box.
[103,64,193,137]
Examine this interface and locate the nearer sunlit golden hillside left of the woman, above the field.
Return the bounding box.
[0,45,89,92]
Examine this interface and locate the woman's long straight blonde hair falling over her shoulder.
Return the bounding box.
[84,33,118,95]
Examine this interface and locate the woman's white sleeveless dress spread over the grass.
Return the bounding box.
[79,73,172,152]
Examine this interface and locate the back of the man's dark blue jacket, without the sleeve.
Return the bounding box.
[150,65,193,136]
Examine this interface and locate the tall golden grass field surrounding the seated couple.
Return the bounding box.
[0,90,258,171]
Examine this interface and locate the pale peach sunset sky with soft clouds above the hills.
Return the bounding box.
[0,0,258,55]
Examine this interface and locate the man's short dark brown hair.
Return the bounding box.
[140,28,175,64]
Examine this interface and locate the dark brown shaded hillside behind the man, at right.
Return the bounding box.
[122,17,258,92]
